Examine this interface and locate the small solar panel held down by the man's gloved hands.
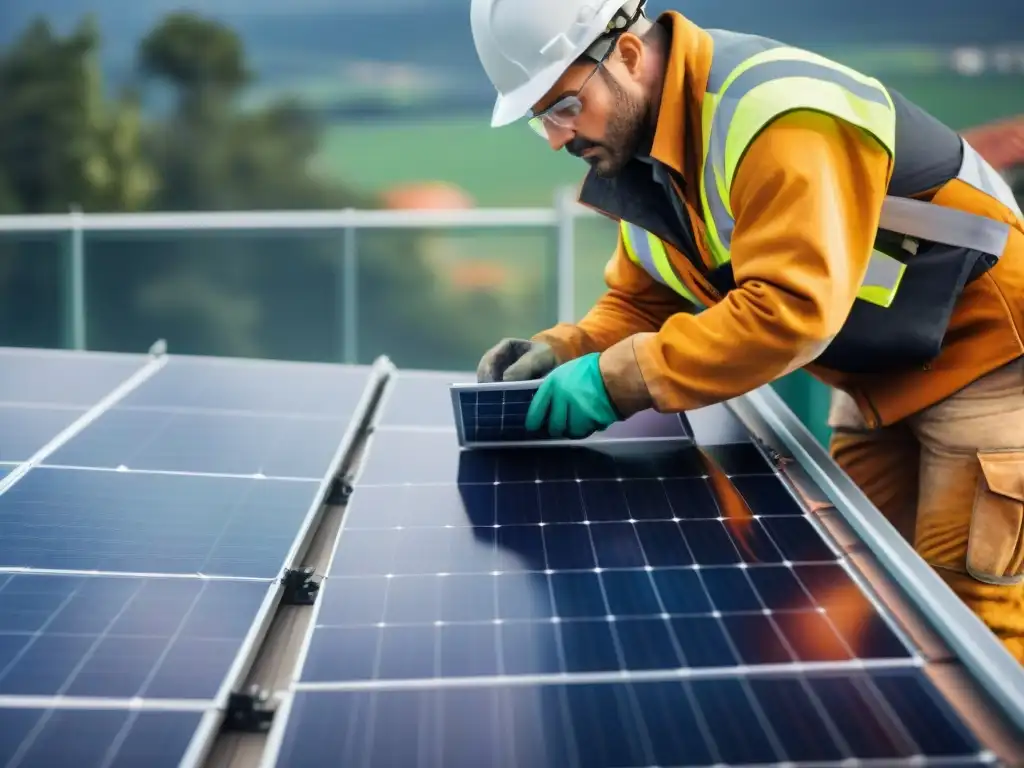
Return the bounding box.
[450,381,693,447]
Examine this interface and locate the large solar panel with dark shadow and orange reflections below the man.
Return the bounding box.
[264,374,991,767]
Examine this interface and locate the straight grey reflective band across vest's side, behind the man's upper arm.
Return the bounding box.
[879,196,1010,256]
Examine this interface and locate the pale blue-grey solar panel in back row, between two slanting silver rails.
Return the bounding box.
[47,358,367,480]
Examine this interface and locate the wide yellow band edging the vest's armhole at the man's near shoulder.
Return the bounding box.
[716,77,896,191]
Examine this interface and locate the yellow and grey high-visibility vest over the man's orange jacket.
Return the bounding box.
[620,30,1021,374]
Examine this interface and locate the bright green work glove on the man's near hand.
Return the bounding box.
[526,352,620,439]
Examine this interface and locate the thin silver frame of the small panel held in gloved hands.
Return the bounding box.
[449,379,694,449]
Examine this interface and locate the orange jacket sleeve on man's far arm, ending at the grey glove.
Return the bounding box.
[534,228,694,362]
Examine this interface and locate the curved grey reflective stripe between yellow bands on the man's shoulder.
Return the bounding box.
[703,60,889,250]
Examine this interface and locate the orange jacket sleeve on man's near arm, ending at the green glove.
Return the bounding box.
[601,112,891,414]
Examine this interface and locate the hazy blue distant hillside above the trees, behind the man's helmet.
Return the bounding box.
[0,0,1024,111]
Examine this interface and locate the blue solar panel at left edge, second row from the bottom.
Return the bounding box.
[0,574,268,700]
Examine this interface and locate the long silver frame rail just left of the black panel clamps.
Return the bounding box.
[172,355,395,766]
